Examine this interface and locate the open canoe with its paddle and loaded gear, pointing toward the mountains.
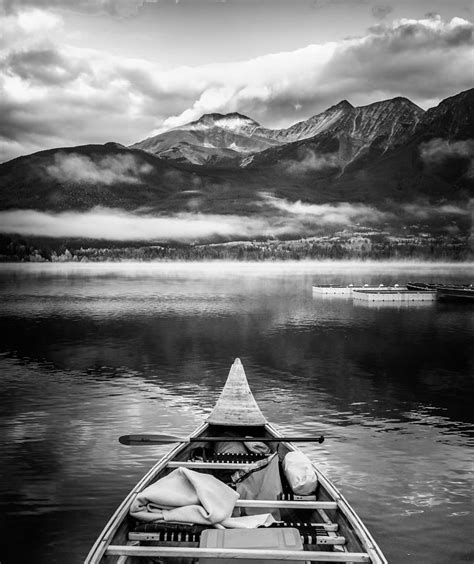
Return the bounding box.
[85,359,387,564]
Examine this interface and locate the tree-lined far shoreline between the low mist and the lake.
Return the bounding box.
[0,231,474,263]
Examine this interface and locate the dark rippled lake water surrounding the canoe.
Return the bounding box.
[0,263,474,564]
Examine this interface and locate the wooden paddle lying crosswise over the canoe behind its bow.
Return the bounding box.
[119,434,324,446]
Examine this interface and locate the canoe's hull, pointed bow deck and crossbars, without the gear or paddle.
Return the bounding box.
[85,359,387,564]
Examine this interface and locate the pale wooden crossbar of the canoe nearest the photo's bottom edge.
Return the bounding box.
[106,545,370,563]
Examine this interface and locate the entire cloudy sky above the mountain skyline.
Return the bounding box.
[0,0,474,162]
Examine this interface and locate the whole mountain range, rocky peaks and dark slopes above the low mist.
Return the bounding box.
[0,89,474,240]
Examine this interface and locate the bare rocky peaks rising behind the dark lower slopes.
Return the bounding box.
[131,96,424,166]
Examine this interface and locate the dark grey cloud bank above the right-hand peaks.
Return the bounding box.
[321,16,473,107]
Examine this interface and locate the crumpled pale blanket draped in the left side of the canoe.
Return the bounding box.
[130,468,273,528]
